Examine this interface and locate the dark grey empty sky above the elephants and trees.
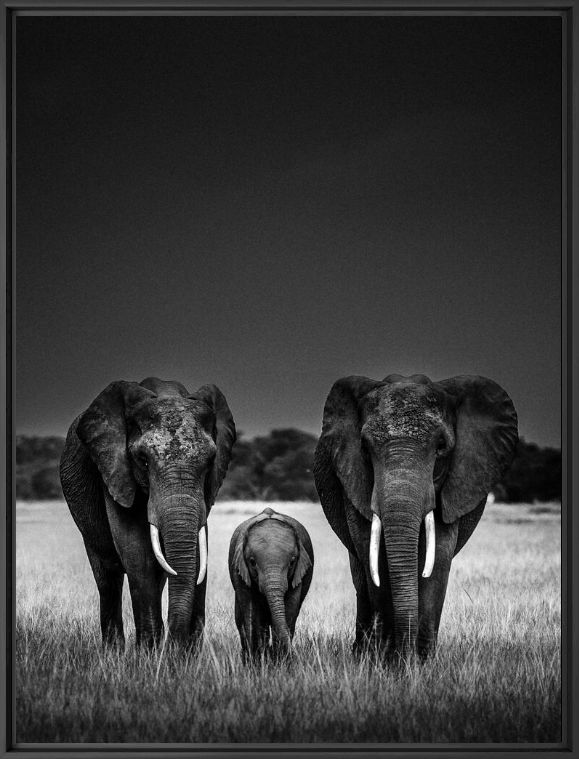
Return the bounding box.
[16,16,561,446]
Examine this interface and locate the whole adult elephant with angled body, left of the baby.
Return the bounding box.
[60,377,236,648]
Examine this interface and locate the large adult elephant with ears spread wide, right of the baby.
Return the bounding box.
[314,374,518,657]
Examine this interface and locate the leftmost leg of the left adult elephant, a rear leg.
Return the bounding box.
[85,542,125,648]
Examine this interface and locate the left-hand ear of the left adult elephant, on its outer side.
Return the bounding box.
[76,380,154,508]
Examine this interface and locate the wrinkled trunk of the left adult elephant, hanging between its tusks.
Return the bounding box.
[149,492,207,642]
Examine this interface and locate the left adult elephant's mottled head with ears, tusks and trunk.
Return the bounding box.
[76,377,235,637]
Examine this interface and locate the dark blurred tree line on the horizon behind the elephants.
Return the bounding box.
[16,428,562,503]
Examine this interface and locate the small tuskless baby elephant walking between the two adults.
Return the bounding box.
[229,508,314,658]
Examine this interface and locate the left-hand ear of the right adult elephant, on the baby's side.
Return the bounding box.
[316,376,383,519]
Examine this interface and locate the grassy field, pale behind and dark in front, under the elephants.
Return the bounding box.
[15,502,561,743]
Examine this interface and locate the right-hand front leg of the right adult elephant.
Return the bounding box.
[416,519,458,659]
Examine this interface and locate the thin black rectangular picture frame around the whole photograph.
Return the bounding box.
[0,0,579,759]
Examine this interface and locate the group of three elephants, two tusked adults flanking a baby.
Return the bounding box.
[60,374,518,660]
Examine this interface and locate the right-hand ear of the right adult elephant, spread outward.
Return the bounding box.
[437,376,519,523]
